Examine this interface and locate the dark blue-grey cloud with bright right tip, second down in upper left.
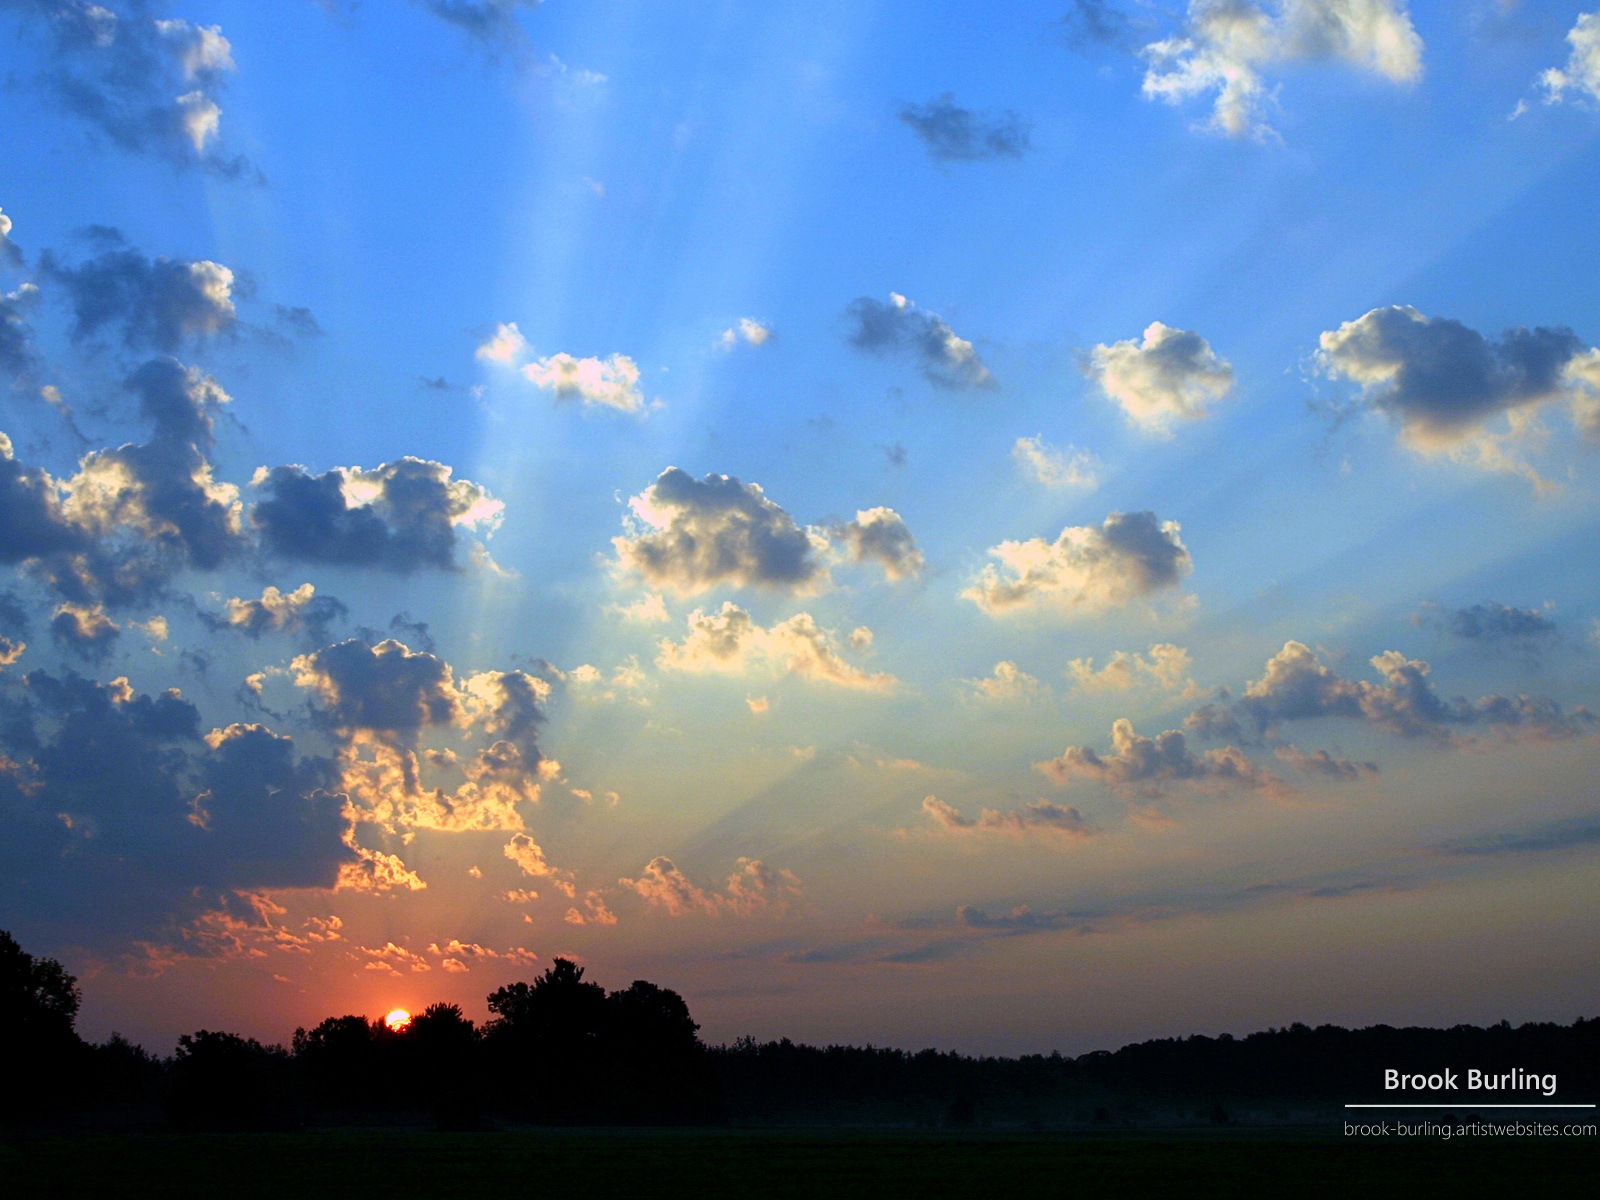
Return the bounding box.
[40,250,238,352]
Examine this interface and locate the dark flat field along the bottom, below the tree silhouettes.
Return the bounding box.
[0,1130,1600,1200]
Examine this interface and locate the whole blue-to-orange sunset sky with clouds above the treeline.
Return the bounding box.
[0,0,1600,1053]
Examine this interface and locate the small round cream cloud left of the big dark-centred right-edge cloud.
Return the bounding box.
[1086,322,1234,437]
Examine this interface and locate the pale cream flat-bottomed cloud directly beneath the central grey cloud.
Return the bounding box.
[656,600,898,691]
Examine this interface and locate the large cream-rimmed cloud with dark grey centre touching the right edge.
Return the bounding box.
[1317,306,1600,474]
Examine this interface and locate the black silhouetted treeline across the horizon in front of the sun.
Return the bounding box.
[0,931,1600,1128]
